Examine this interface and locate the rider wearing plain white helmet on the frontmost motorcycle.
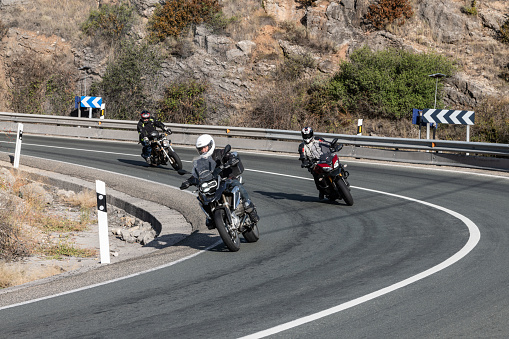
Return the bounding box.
[180,134,260,229]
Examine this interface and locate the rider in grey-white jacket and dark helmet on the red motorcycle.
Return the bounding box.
[299,127,340,200]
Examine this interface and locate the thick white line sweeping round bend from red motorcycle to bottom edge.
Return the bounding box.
[240,186,481,339]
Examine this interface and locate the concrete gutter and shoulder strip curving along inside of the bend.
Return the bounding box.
[0,153,205,247]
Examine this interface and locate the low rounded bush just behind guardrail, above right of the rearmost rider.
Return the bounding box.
[159,80,207,124]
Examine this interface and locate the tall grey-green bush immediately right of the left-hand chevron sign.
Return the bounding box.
[91,40,162,120]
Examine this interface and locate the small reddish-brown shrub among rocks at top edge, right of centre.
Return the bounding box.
[366,0,414,29]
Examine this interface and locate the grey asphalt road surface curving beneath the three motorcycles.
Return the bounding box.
[0,135,509,338]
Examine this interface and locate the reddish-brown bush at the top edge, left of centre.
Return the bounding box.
[148,0,220,41]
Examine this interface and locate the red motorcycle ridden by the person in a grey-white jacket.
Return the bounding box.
[311,139,353,206]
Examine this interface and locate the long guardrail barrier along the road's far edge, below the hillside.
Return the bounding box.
[0,112,509,171]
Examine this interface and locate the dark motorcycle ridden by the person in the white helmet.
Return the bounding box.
[187,145,260,252]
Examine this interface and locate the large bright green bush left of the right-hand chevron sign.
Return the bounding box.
[309,47,455,119]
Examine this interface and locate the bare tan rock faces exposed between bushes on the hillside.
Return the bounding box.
[0,0,509,123]
